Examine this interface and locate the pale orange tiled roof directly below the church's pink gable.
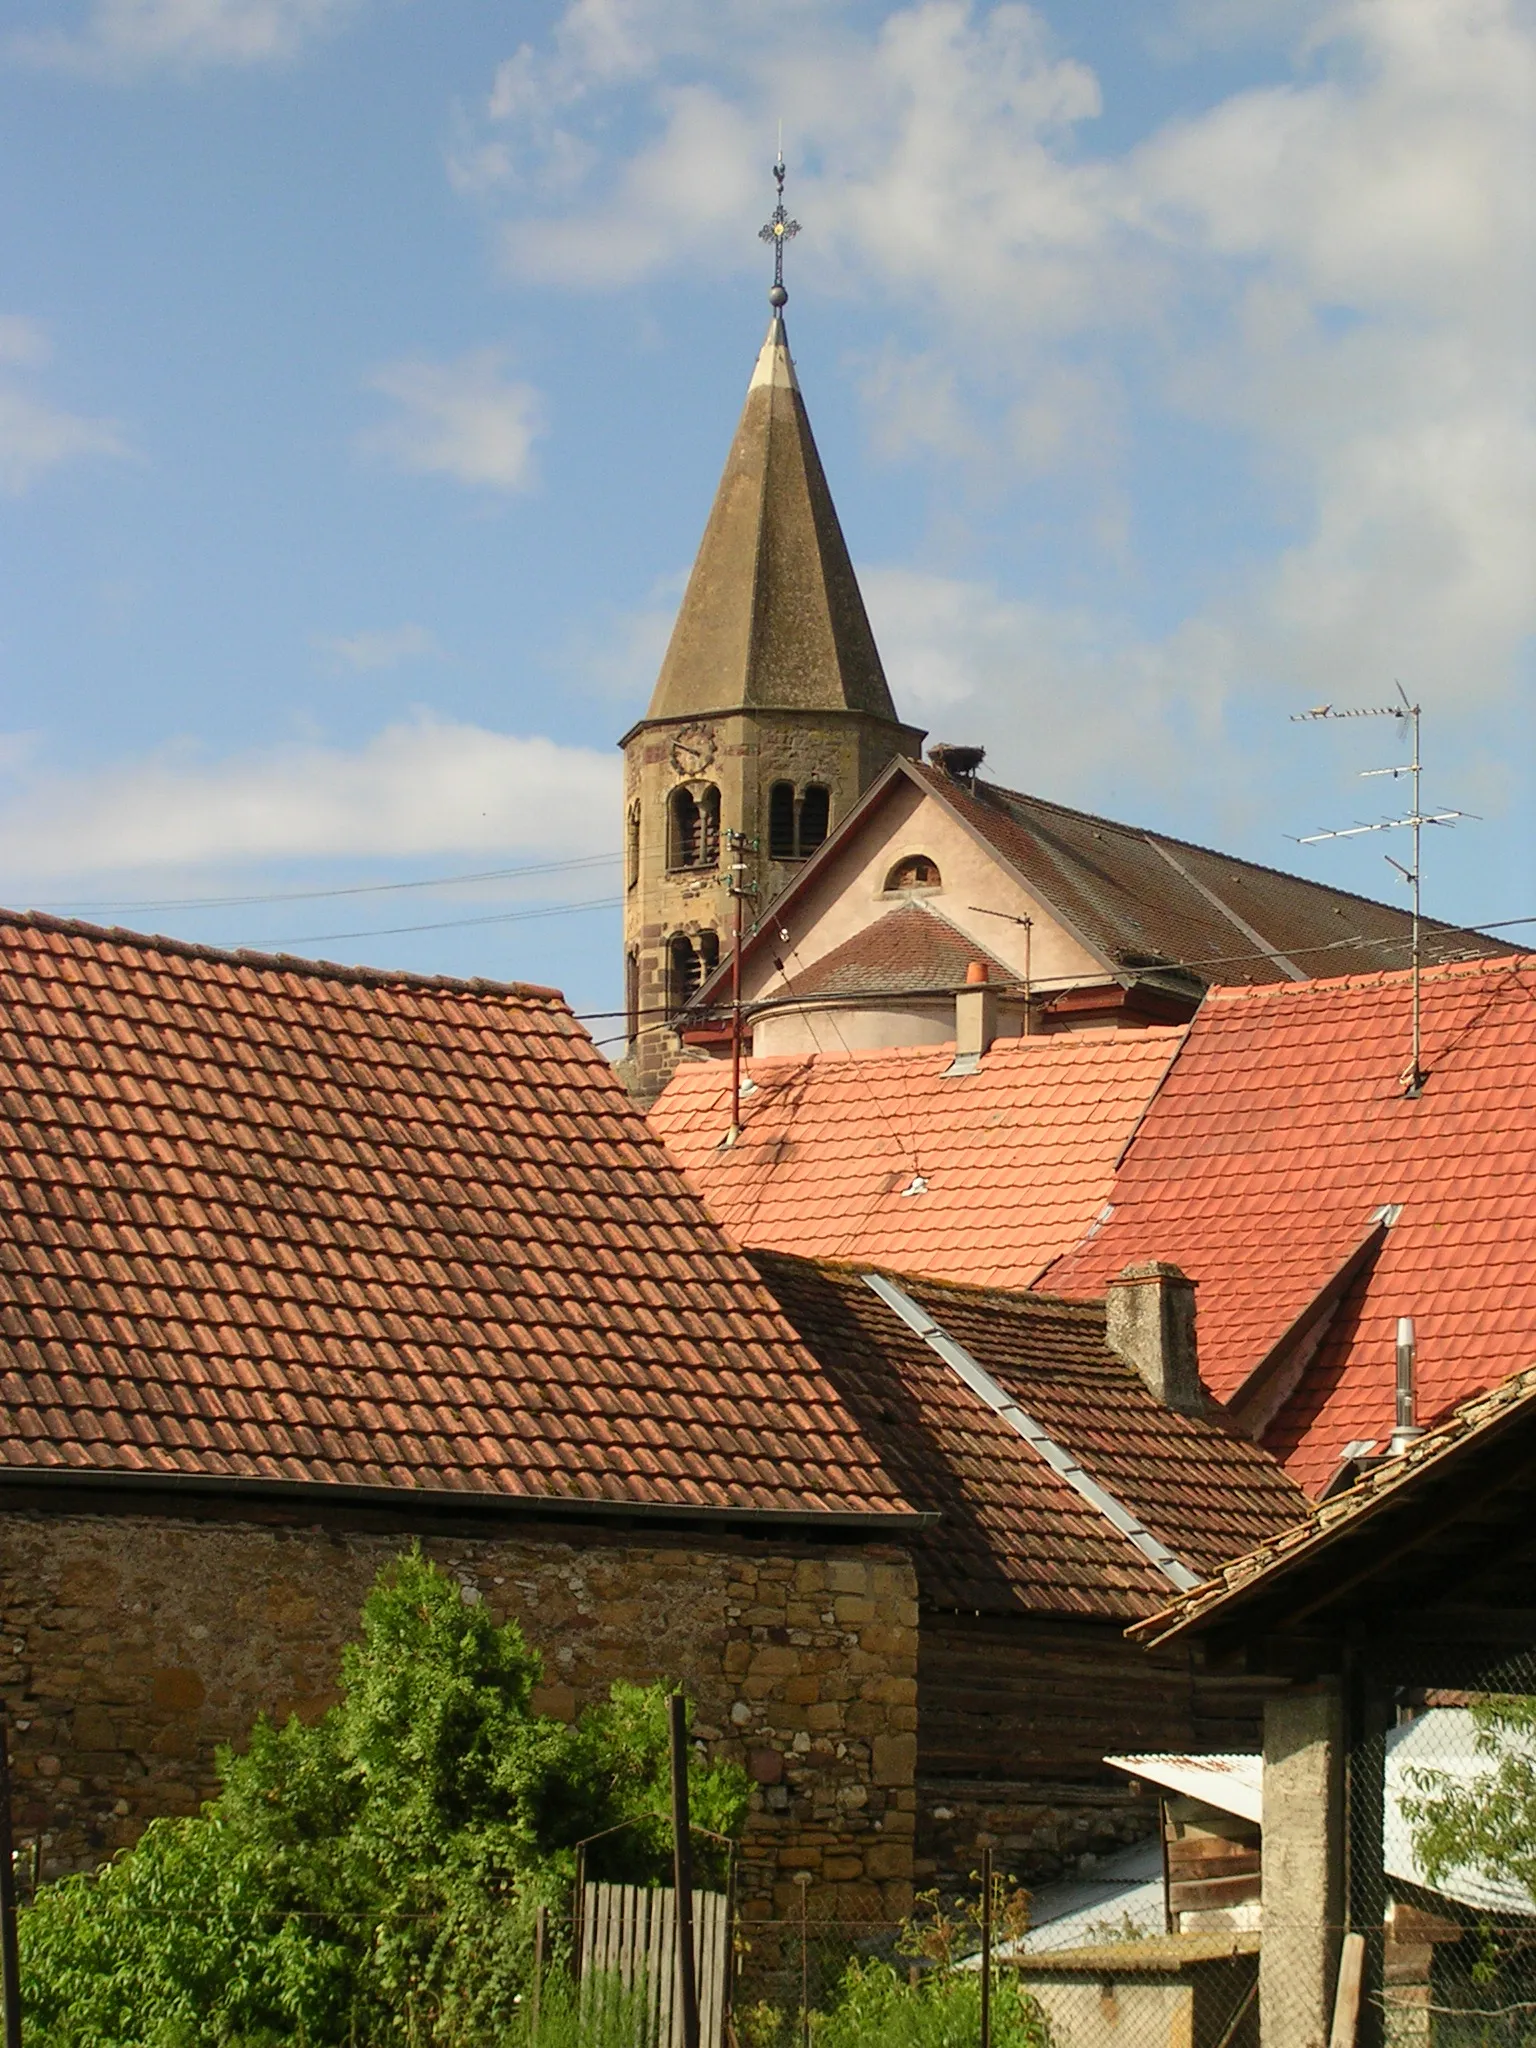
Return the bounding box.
[651,1030,1184,1286]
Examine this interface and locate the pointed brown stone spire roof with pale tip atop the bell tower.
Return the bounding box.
[647,315,897,725]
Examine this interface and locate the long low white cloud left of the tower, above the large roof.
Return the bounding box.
[0,717,618,899]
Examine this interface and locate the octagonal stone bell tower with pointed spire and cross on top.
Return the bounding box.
[621,162,924,1102]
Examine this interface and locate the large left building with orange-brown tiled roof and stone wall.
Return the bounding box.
[0,915,920,1919]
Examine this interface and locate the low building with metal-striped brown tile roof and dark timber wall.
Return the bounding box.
[754,1251,1307,1884]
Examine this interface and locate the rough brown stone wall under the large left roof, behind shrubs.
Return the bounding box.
[0,1509,918,1919]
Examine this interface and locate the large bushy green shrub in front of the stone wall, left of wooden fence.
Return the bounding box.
[20,1550,748,2048]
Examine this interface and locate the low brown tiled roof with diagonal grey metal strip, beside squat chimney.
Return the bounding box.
[754,1253,1309,1620]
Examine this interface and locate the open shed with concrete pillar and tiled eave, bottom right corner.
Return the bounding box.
[1130,1348,1536,2048]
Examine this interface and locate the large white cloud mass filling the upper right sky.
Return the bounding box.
[468,0,1536,720]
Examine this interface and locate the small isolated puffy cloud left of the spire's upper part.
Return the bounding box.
[362,348,543,492]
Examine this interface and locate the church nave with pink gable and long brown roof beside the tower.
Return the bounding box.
[678,748,1509,1053]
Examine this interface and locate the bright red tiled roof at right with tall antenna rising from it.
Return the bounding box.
[1047,956,1536,1491]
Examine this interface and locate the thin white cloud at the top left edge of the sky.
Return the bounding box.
[6,0,356,78]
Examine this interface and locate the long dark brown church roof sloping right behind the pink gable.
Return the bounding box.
[907,764,1511,987]
